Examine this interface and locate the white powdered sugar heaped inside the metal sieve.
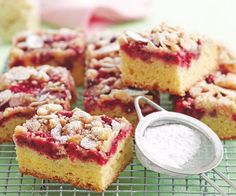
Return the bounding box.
[142,124,201,169]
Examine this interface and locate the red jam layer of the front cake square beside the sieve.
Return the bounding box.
[15,113,133,165]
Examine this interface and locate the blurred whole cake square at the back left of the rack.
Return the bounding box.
[8,28,85,85]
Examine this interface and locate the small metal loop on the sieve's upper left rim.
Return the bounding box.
[134,96,166,120]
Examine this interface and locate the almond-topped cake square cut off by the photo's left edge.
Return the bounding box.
[0,65,76,143]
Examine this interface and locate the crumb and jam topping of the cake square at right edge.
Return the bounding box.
[172,70,236,119]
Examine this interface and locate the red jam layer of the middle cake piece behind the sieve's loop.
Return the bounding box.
[84,92,160,115]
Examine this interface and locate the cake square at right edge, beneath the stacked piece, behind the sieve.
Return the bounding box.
[171,58,236,140]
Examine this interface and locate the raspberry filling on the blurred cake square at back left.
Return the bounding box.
[10,34,84,70]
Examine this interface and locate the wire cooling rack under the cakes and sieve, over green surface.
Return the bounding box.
[0,95,236,196]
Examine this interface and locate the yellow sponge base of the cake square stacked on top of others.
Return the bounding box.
[121,42,218,95]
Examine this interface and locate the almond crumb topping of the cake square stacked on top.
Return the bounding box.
[119,23,202,52]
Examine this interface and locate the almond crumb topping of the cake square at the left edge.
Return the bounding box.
[0,65,72,119]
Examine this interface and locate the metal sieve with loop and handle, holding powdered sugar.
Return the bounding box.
[134,96,236,195]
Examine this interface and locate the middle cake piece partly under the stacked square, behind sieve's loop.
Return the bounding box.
[84,33,159,126]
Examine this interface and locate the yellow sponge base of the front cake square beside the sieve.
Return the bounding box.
[16,135,133,192]
